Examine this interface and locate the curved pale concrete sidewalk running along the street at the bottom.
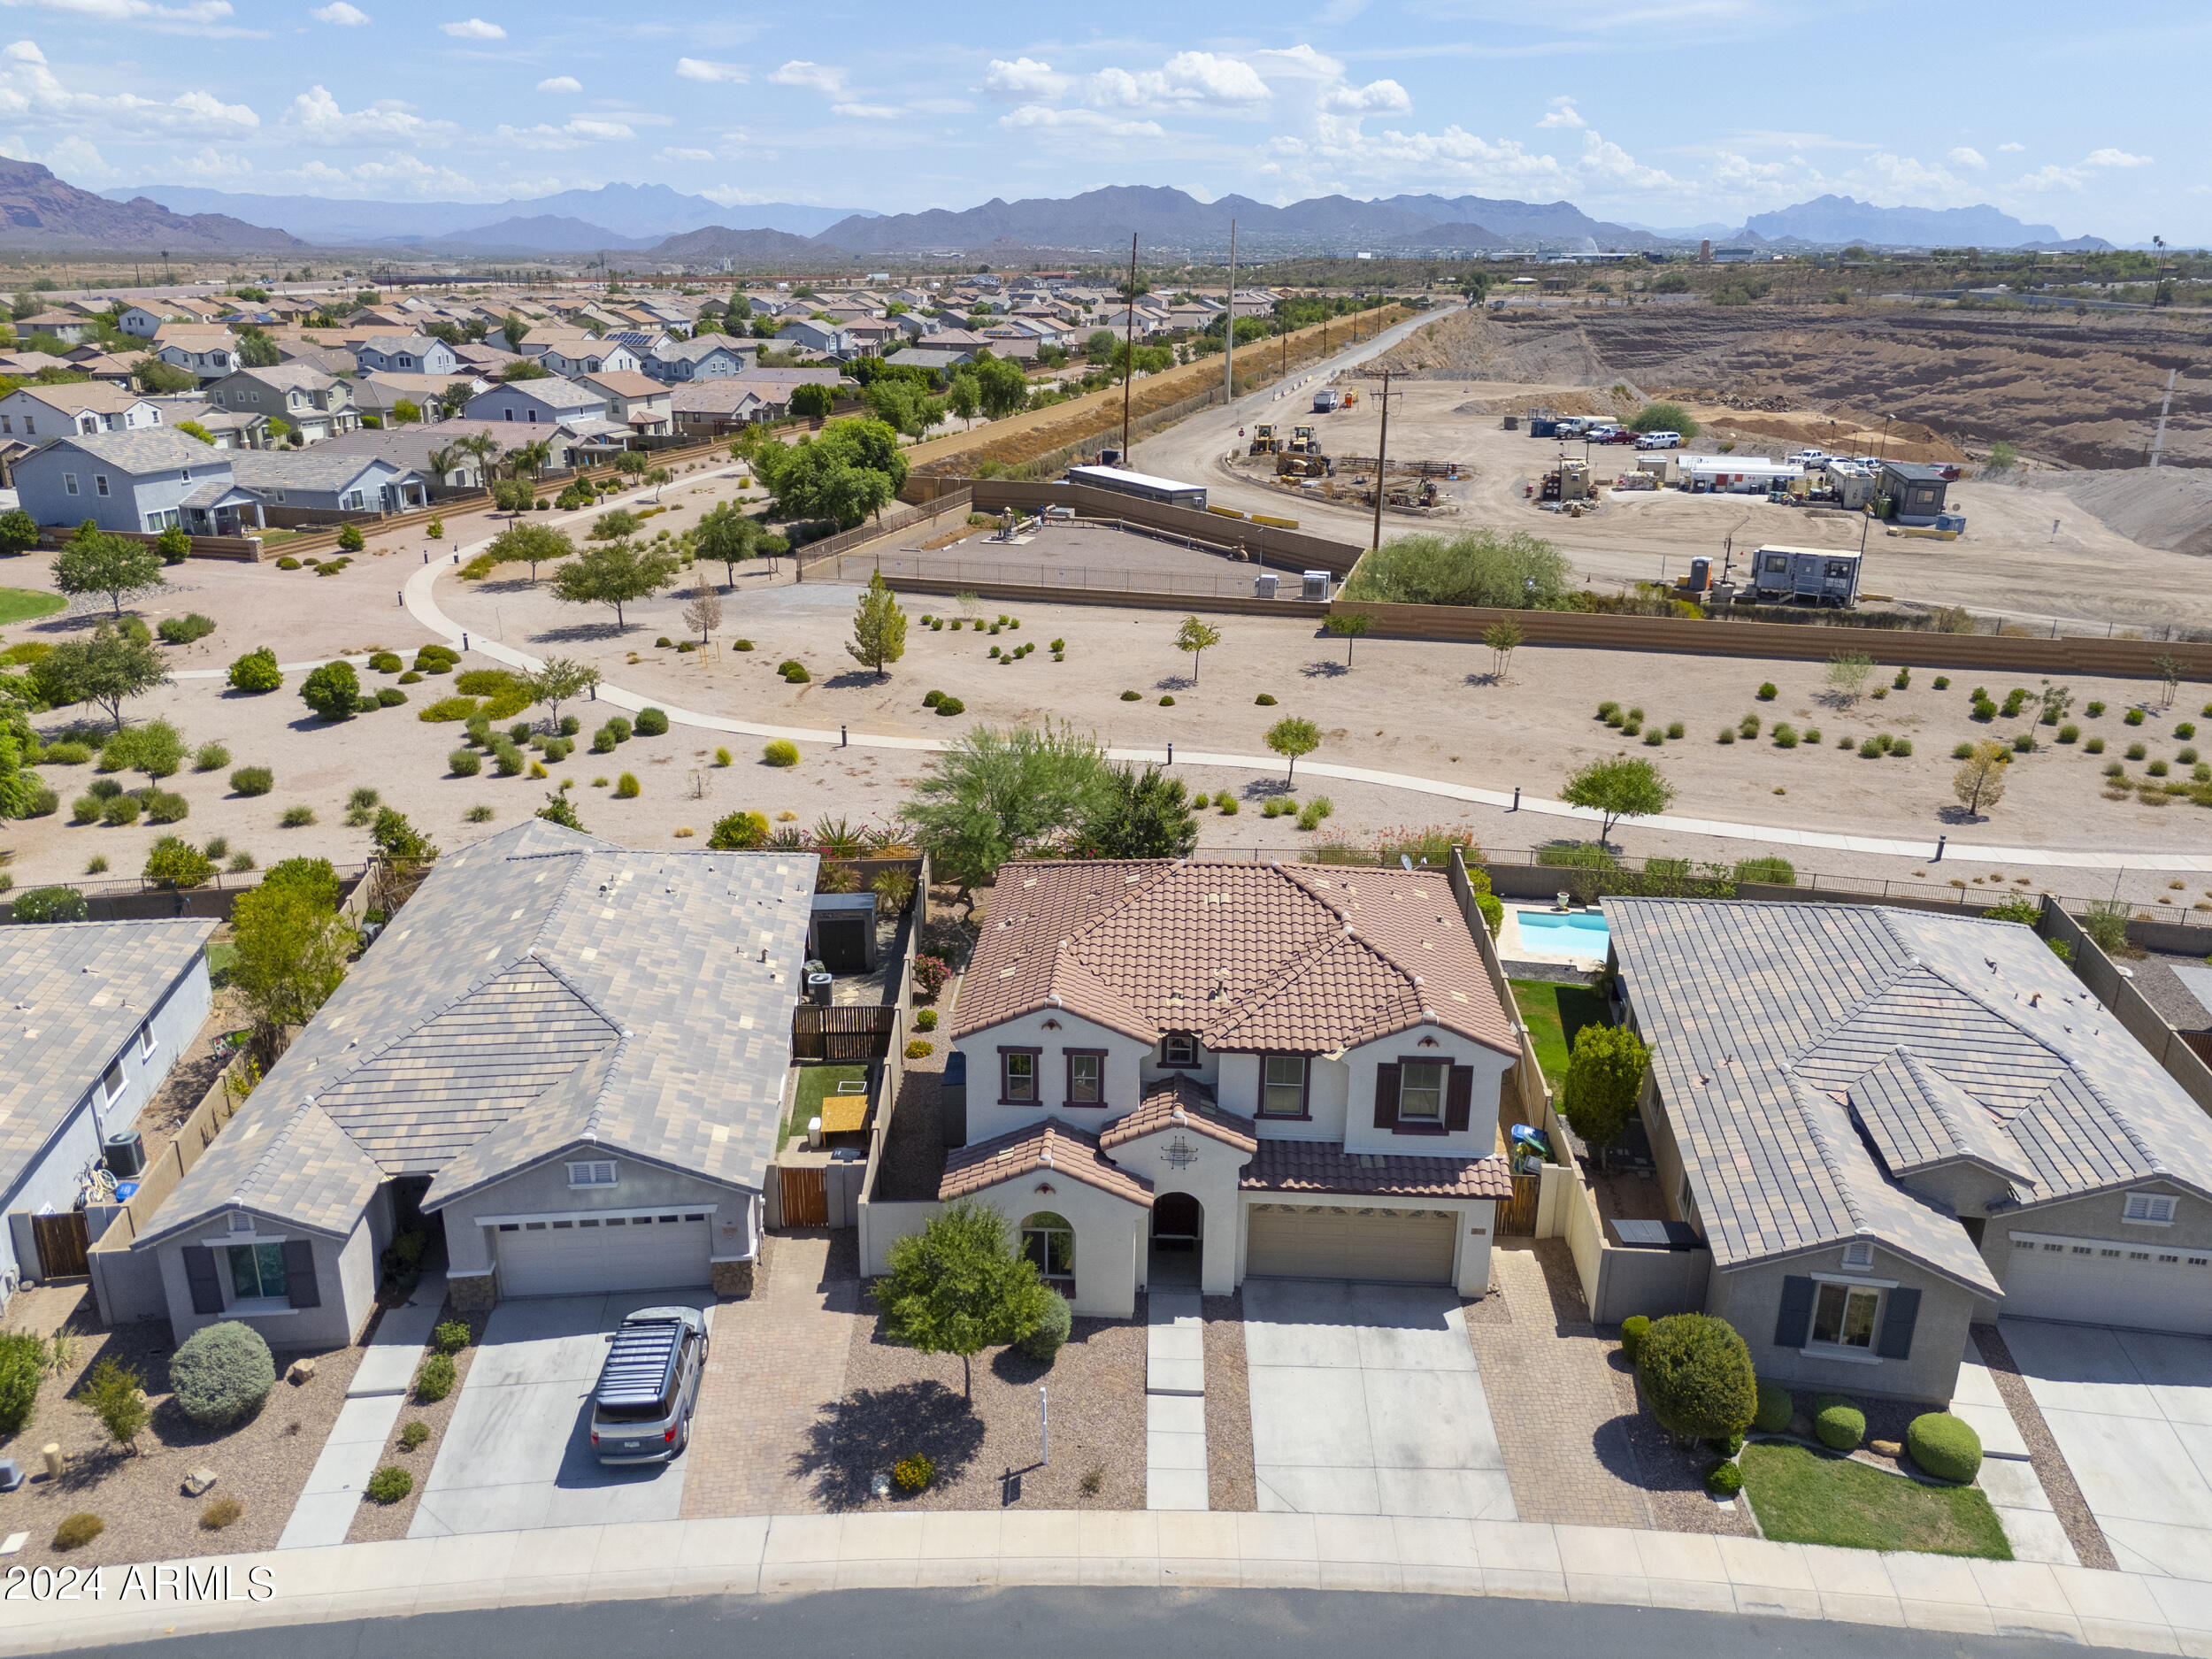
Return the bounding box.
[0,1511,2212,1659]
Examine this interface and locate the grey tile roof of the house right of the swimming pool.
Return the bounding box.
[1606,898,2212,1294]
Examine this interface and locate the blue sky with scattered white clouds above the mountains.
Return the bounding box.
[0,0,2212,243]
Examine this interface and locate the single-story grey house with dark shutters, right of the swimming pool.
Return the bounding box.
[1604,898,2212,1401]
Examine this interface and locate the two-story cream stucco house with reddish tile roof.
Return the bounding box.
[898,858,1520,1318]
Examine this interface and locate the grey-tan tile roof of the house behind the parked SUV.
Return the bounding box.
[142,818,817,1243]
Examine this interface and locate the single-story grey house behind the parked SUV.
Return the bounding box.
[133,818,817,1348]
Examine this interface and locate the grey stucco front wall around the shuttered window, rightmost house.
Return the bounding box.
[1706,1246,1993,1405]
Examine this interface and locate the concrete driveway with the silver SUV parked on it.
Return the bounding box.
[407,1290,715,1538]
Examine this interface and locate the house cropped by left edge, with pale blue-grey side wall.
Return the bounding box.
[0,929,215,1303]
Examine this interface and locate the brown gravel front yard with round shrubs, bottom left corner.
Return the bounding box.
[0,1287,363,1566]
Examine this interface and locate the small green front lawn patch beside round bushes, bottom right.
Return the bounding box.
[1743,1440,2013,1562]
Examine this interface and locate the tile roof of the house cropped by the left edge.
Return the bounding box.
[0,925,215,1193]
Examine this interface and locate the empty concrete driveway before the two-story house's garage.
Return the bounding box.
[1243,1279,1516,1520]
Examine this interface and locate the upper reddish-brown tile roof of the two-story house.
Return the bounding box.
[954,858,1520,1056]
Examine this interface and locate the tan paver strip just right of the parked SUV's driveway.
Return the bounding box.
[684,1228,861,1517]
